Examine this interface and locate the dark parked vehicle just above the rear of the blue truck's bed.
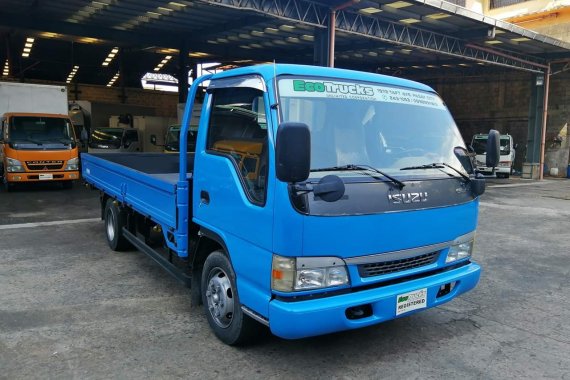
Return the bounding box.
[88,128,143,153]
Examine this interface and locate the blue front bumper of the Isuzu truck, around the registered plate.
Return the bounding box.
[269,262,481,339]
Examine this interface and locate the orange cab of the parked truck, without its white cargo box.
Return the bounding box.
[0,112,79,190]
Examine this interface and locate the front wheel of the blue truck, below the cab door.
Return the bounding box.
[200,251,258,346]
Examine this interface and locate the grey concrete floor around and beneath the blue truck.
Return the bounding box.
[0,179,570,379]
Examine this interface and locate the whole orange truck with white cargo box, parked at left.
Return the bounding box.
[0,82,79,191]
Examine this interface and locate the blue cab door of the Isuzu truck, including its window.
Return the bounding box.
[193,76,274,315]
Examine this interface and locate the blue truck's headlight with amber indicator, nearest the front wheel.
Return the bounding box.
[271,255,349,292]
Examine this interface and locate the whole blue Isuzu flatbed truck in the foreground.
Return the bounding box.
[82,65,499,345]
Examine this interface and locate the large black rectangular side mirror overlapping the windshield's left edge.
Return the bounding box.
[275,122,311,183]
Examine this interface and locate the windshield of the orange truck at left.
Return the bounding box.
[8,116,73,145]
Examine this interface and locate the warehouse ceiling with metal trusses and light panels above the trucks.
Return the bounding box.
[0,0,570,87]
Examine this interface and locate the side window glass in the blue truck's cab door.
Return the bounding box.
[206,88,268,205]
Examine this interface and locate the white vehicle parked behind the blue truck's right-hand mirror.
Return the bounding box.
[471,133,516,178]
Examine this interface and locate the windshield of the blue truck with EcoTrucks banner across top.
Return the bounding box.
[279,78,465,178]
